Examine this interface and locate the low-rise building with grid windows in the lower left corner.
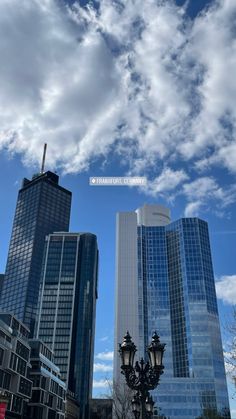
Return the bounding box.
[0,312,66,419]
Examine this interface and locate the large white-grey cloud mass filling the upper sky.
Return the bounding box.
[0,0,236,214]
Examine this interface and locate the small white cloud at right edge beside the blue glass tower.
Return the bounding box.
[216,275,236,304]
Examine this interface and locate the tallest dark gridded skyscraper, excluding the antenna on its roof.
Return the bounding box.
[1,172,71,332]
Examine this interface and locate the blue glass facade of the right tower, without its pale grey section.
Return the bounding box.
[138,218,230,419]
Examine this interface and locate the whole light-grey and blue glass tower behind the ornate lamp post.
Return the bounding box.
[114,205,230,419]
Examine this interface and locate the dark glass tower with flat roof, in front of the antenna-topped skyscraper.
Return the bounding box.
[37,233,98,419]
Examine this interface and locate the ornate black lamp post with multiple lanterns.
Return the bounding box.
[119,332,165,419]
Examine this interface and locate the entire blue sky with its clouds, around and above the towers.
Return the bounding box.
[0,0,236,418]
